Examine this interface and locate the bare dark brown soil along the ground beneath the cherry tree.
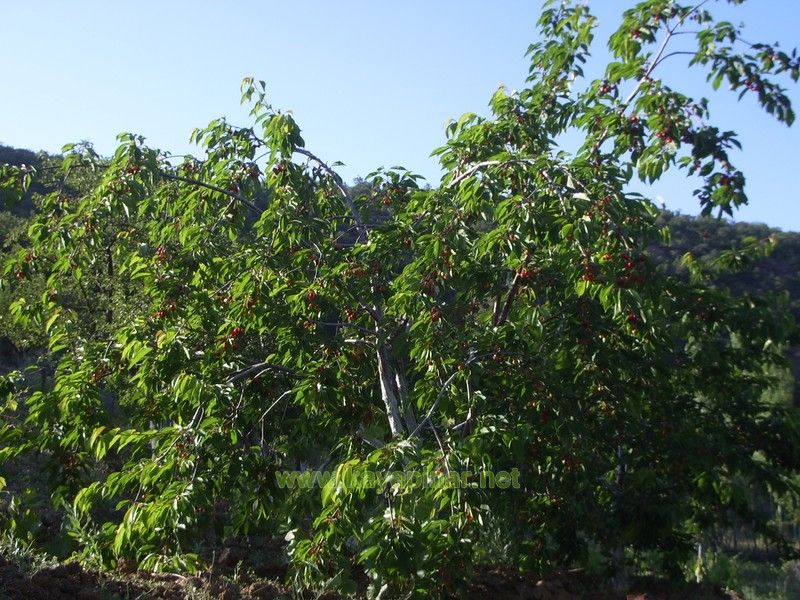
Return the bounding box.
[0,555,741,600]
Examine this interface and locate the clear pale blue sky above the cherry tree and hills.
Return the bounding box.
[0,0,800,230]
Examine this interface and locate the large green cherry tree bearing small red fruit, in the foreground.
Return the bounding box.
[0,0,800,597]
